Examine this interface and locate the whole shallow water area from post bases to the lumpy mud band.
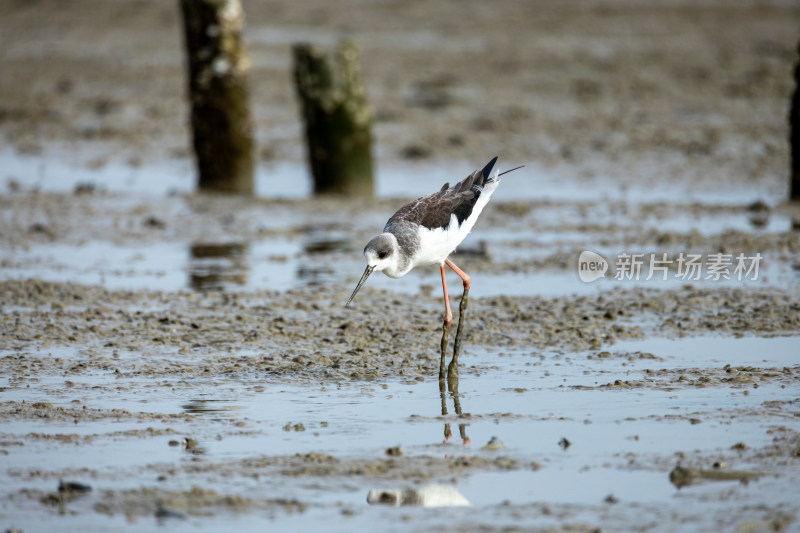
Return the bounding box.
[0,149,800,297]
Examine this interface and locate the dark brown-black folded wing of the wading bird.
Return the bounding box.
[386,157,497,229]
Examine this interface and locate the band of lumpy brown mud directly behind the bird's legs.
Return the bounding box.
[0,280,800,379]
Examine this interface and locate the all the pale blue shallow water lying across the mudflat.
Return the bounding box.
[0,145,800,531]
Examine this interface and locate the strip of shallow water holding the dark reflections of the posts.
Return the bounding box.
[0,227,798,297]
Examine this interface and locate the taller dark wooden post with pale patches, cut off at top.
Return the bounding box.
[180,0,254,195]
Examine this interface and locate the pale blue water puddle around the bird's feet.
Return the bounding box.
[4,337,797,463]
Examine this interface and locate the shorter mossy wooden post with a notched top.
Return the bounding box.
[293,41,374,196]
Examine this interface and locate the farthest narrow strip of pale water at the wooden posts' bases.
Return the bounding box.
[0,145,784,205]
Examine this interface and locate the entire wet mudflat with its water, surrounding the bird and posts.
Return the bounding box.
[0,0,800,533]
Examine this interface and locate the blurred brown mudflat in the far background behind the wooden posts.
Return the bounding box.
[0,0,800,190]
